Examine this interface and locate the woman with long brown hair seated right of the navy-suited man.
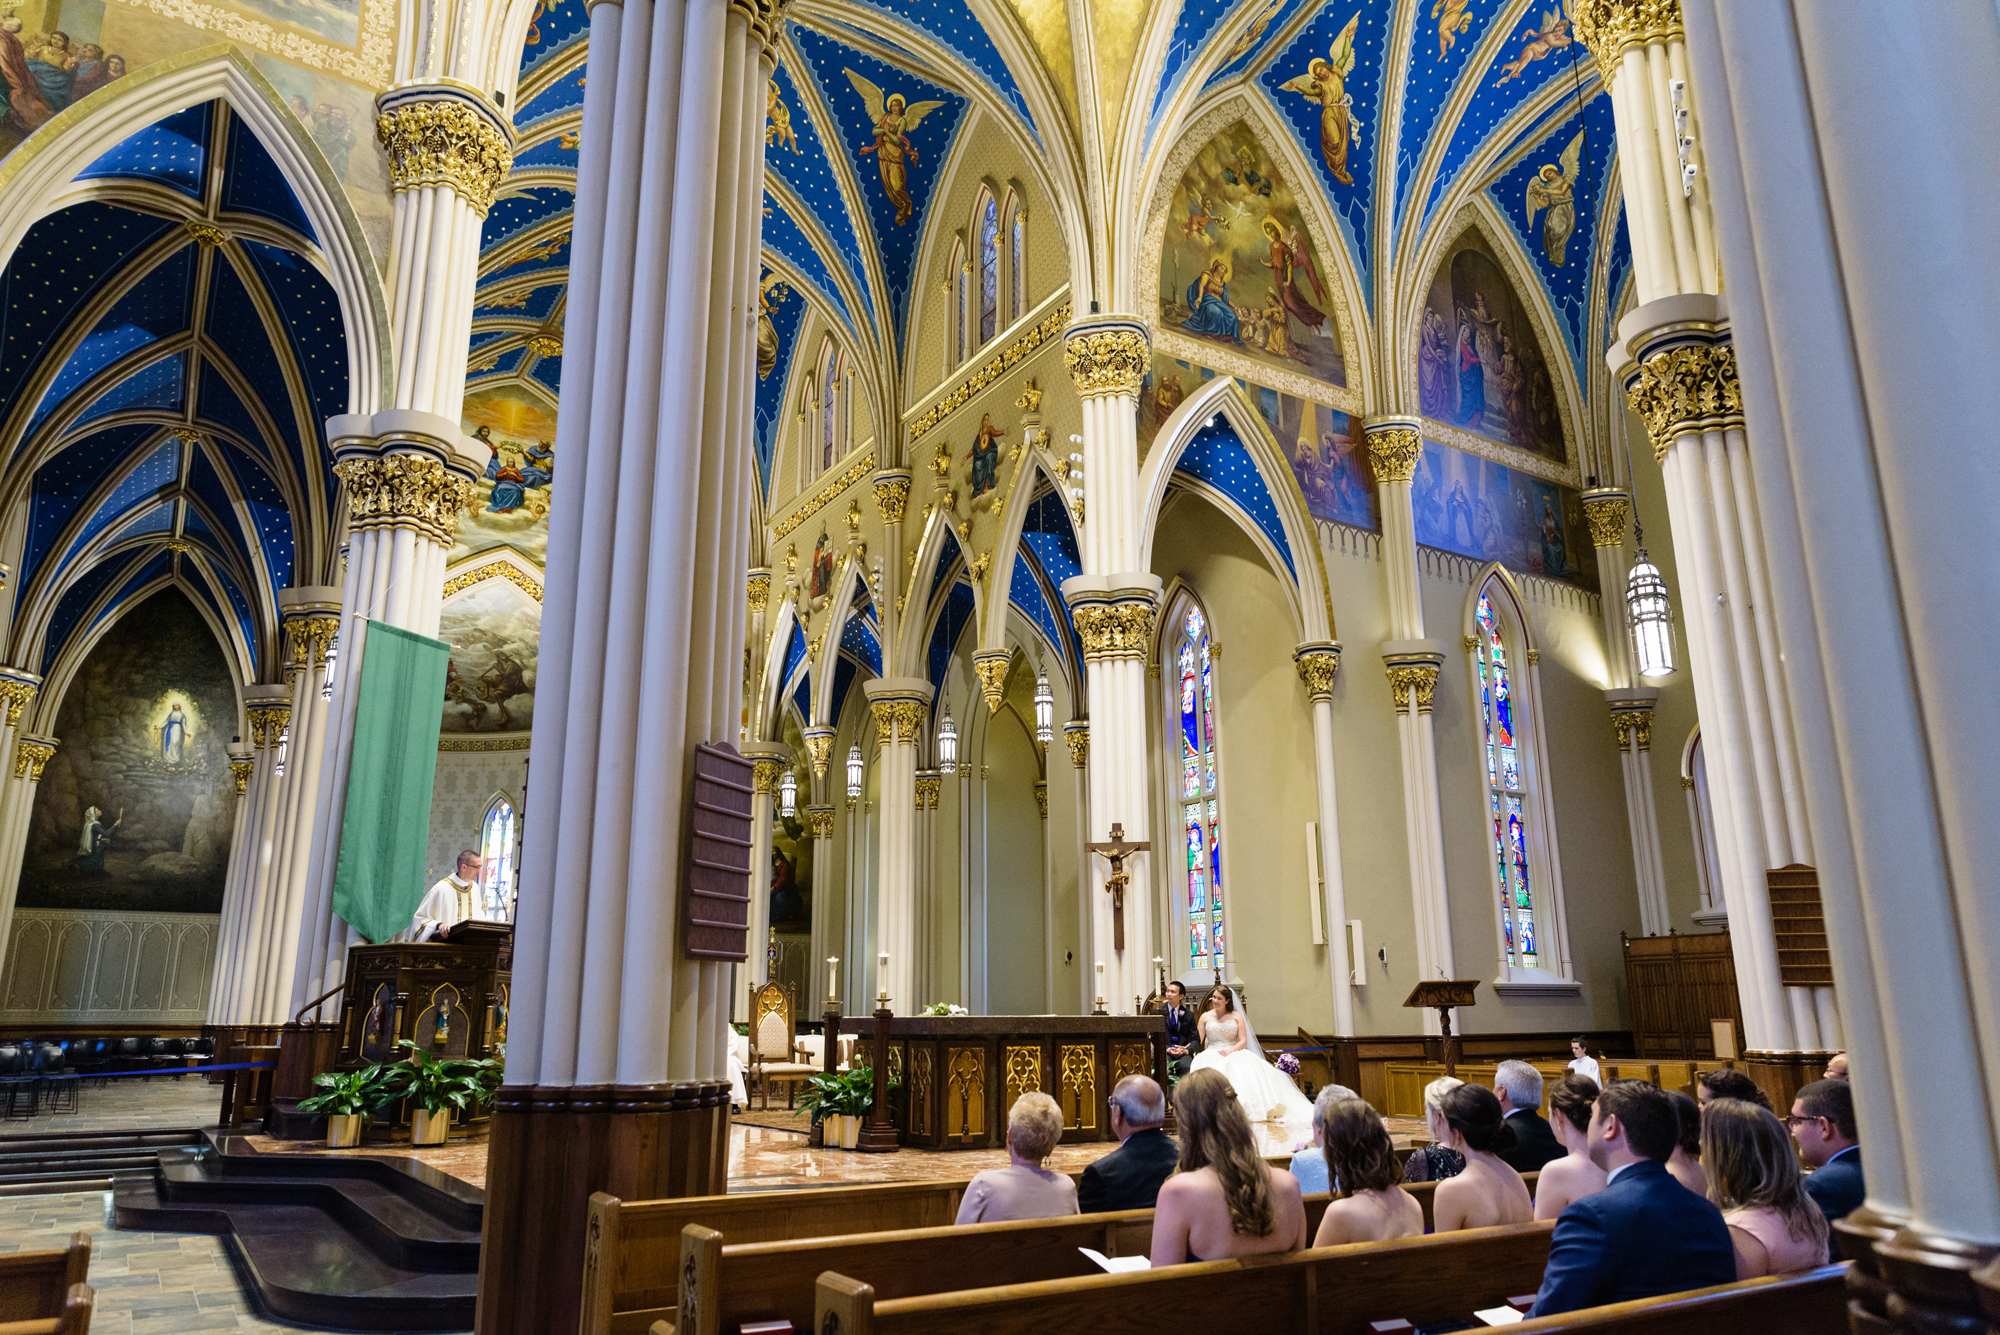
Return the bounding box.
[1702,1099,1828,1279]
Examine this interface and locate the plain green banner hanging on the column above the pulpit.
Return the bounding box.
[334,622,452,941]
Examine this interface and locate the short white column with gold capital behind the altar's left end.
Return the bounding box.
[858,677,932,1015]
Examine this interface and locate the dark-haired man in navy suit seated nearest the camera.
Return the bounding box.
[1528,1079,1736,1317]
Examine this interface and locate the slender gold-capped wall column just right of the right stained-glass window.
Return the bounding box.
[1584,486,1674,935]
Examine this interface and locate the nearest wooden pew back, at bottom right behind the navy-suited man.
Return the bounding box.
[1508,1263,1848,1335]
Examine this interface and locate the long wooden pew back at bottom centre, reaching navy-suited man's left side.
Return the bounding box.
[804,1223,1554,1335]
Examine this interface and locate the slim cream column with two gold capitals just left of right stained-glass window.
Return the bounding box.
[1364,418,1458,1011]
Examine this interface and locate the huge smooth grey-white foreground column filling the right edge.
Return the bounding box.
[1688,0,2000,1311]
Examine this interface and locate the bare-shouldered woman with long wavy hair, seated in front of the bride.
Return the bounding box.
[1146,1071,1306,1267]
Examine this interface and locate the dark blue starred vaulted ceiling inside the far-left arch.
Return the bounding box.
[0,102,348,681]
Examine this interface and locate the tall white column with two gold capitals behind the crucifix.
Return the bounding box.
[1062,316,1164,1013]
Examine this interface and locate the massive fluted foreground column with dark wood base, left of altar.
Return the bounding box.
[476,0,784,1335]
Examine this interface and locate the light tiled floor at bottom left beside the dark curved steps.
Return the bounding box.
[0,1191,468,1335]
